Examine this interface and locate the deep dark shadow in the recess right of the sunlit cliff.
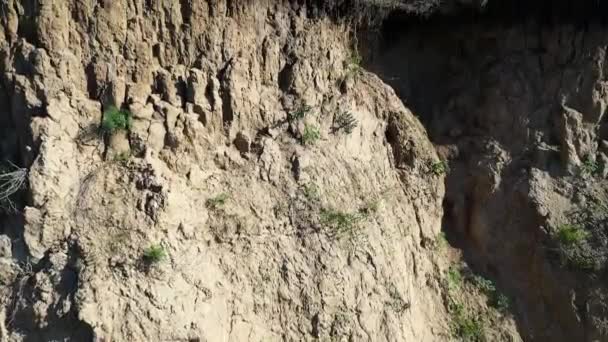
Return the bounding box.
[359,0,608,341]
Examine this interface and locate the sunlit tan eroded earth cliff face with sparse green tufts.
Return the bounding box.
[0,0,464,341]
